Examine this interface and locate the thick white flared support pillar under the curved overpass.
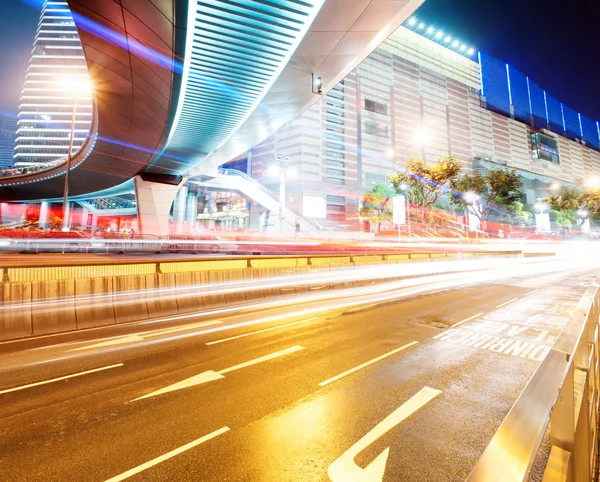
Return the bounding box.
[134,176,183,236]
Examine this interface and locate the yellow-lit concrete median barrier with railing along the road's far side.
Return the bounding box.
[0,251,522,340]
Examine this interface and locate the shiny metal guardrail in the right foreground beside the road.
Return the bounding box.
[467,278,600,482]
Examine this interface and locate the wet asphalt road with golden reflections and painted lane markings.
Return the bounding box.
[0,254,598,482]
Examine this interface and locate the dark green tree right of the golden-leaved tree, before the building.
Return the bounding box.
[450,169,523,223]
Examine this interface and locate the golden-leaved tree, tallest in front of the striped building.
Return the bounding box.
[390,154,461,223]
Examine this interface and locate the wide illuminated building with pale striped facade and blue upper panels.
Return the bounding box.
[252,24,600,229]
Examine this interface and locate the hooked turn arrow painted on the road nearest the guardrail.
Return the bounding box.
[327,387,442,482]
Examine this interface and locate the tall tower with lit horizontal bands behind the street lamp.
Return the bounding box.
[14,1,92,166]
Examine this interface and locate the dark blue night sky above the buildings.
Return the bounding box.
[0,0,600,120]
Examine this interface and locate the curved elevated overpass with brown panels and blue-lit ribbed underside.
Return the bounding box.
[0,0,423,201]
